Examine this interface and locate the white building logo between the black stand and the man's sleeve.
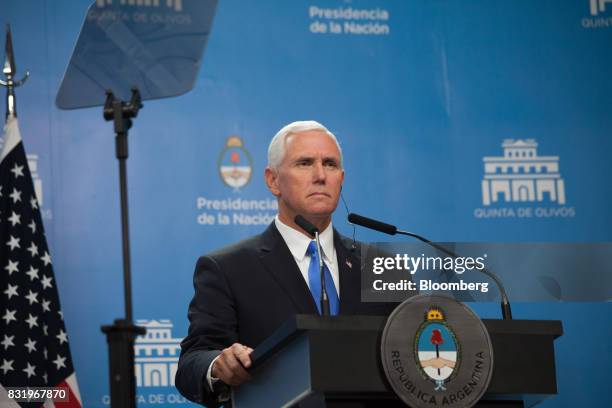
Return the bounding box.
[134,320,182,387]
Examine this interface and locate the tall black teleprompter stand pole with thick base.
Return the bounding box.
[101,88,146,408]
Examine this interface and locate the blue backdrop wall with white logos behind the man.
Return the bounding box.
[1,0,612,407]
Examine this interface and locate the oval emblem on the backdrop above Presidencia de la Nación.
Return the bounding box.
[218,136,253,191]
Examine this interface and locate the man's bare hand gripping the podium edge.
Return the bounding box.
[211,343,253,387]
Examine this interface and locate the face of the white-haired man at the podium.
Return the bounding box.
[265,130,344,228]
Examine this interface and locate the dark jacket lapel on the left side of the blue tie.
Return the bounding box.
[259,222,318,314]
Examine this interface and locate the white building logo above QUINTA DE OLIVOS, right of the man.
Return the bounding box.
[482,140,568,206]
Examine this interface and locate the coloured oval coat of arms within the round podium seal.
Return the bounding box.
[414,307,461,391]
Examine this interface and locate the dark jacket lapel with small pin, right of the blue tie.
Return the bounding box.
[334,230,361,314]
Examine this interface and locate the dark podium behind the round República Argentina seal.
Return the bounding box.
[232,315,563,408]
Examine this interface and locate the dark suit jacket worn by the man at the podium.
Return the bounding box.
[176,223,390,406]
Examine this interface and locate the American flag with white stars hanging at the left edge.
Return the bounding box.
[0,115,82,407]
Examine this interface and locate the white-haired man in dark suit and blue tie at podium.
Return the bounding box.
[176,121,390,406]
